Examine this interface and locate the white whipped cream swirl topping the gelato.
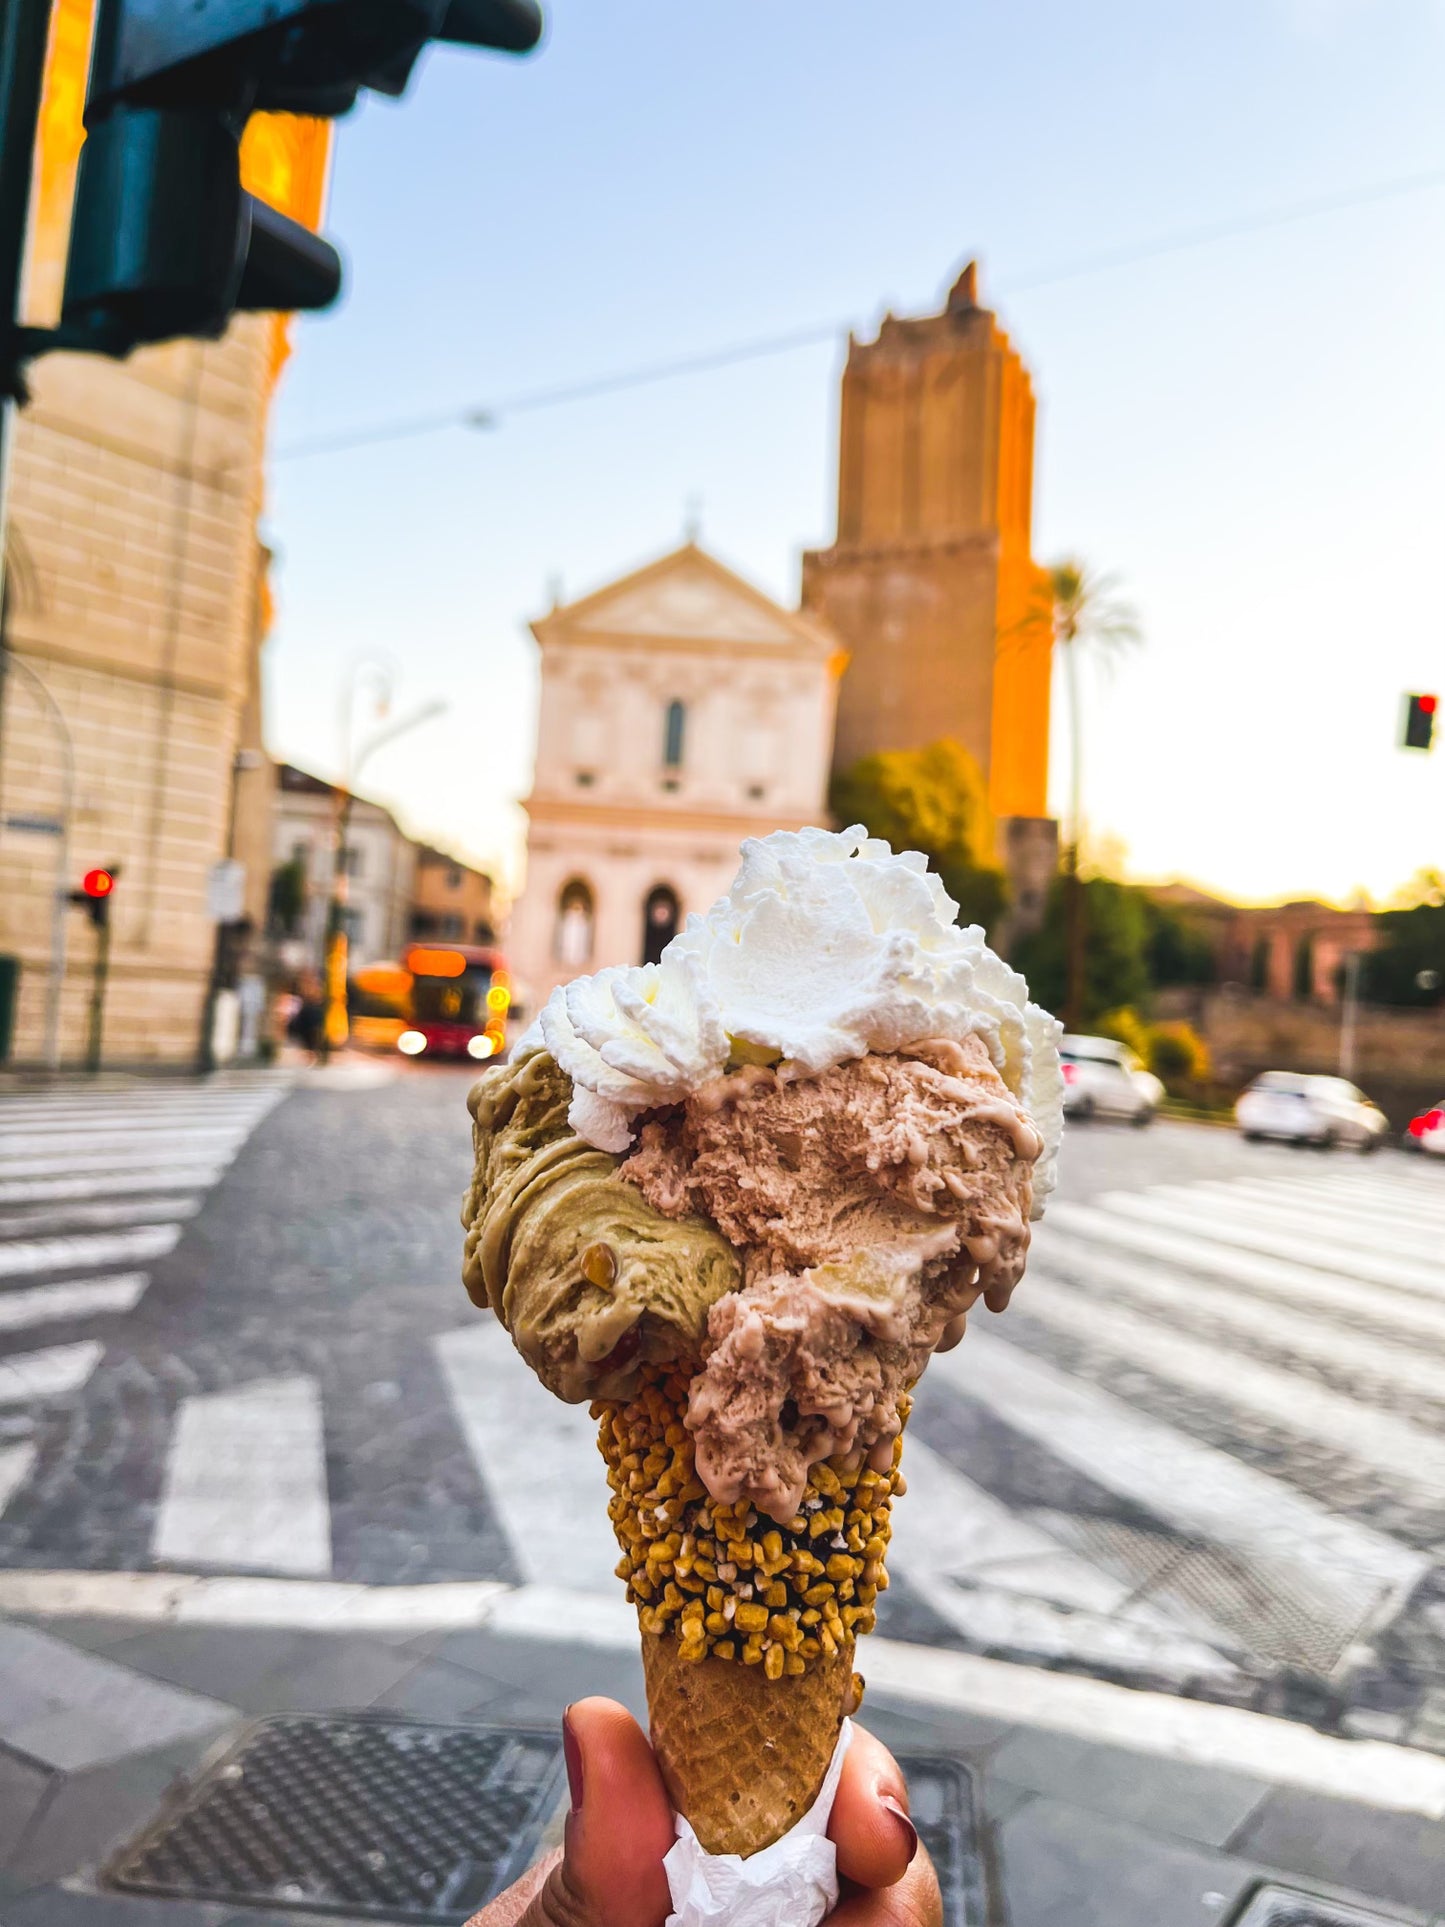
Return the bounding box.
[539,825,1064,1212]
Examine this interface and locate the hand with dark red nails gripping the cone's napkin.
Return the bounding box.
[466,1700,944,1927]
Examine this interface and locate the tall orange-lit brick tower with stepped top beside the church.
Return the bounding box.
[803,262,1052,832]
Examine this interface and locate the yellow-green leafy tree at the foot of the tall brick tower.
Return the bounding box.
[828,740,1008,929]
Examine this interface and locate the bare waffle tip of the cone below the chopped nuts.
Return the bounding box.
[642,1632,854,1854]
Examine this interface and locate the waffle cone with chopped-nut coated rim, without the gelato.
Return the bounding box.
[595,1370,902,1854]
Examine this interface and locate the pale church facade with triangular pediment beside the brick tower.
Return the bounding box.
[509,543,840,1010]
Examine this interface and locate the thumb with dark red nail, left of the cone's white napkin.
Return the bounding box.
[522,1700,674,1927]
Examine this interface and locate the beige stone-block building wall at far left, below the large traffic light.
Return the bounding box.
[0,316,274,1062]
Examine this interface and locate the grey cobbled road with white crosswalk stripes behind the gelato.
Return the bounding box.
[0,1066,1445,1752]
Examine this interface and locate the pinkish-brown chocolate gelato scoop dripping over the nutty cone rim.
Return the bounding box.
[622,1039,1042,1520]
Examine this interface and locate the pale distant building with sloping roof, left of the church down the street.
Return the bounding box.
[272,763,416,967]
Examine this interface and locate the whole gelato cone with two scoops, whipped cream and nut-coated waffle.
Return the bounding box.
[462,831,1062,1857]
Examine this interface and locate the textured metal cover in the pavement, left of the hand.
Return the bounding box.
[102,1715,565,1927]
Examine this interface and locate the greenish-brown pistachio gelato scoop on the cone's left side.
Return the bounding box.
[462,1050,742,1405]
